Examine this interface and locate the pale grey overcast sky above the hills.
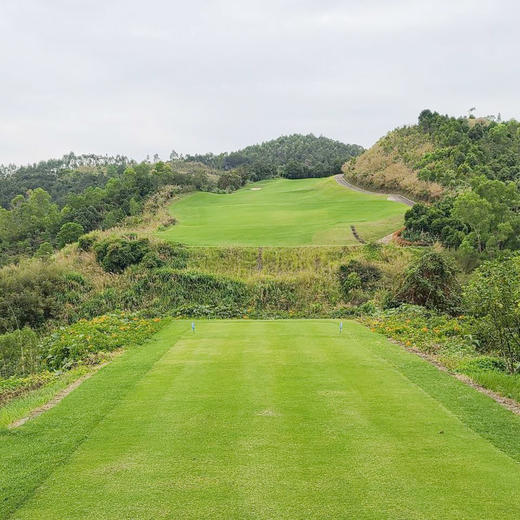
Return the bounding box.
[0,0,520,164]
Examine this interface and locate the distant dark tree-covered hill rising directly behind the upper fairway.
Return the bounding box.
[186,134,363,178]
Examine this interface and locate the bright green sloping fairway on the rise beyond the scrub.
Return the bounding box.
[159,177,408,246]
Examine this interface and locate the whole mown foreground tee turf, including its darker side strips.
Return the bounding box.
[0,320,520,520]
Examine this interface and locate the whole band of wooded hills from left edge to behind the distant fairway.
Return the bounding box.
[0,135,362,265]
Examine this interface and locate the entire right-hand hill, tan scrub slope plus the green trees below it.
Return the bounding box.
[343,110,520,261]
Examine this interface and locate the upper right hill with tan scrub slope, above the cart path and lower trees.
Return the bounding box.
[343,110,520,200]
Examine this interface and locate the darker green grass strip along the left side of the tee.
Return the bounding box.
[0,322,189,519]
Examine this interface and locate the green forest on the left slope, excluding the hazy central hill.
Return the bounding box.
[0,160,216,265]
